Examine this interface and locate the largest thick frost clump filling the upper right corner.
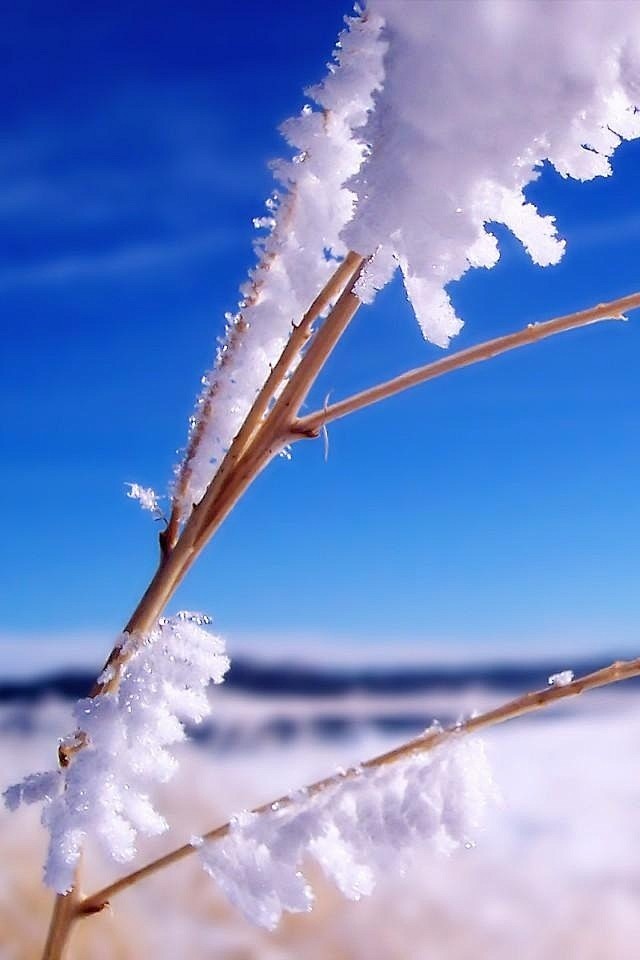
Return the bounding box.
[342,0,640,346]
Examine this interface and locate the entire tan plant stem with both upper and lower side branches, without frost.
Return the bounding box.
[43,278,640,960]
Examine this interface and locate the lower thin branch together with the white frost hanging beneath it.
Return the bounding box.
[78,657,640,925]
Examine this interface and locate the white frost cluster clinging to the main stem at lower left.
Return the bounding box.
[4,612,229,893]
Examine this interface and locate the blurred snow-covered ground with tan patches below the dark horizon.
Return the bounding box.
[0,688,640,960]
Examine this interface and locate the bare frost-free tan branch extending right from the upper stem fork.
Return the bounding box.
[295,293,640,437]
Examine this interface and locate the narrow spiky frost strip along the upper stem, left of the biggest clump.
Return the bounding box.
[175,13,386,515]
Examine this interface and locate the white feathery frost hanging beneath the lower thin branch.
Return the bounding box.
[192,738,495,929]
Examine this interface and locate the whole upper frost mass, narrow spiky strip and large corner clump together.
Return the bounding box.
[174,0,640,517]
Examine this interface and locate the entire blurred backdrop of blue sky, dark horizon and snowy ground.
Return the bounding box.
[0,0,640,960]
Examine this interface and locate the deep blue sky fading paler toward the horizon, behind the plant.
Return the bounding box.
[0,0,640,672]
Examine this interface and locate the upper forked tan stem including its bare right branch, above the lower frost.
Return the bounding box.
[86,284,640,696]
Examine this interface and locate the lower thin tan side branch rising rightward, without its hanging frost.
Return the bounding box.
[79,657,640,915]
